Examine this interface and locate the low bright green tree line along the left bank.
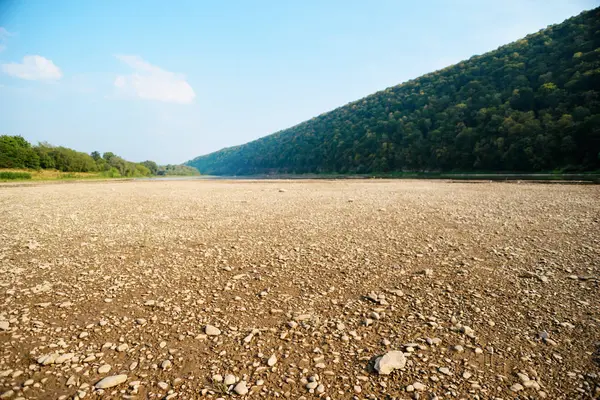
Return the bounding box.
[0,135,199,178]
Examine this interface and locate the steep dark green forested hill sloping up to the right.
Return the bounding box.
[186,8,600,175]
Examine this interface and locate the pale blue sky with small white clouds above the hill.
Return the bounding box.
[0,0,600,164]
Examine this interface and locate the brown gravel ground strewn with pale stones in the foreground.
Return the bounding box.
[0,180,600,400]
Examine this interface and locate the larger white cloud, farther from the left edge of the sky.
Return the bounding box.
[114,55,196,104]
